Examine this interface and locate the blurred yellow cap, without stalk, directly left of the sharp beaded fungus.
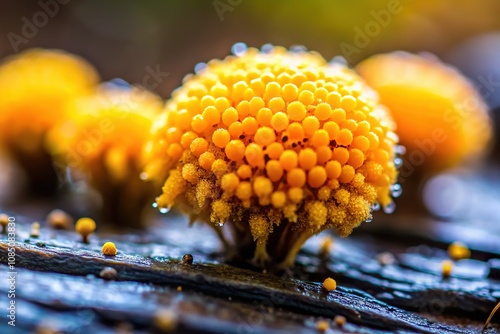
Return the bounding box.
[47,81,163,183]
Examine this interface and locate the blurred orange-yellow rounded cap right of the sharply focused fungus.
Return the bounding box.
[356,52,492,172]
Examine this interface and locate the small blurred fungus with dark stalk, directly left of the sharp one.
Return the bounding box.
[47,81,163,226]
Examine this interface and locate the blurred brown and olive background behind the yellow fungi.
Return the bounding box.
[0,0,500,224]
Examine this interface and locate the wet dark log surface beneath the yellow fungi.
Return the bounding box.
[0,212,500,333]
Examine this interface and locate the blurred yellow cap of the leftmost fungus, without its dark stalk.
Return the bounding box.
[0,49,98,142]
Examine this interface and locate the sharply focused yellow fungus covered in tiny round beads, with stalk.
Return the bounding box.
[146,44,397,267]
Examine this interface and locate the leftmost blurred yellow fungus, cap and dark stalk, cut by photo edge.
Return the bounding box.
[0,49,98,192]
